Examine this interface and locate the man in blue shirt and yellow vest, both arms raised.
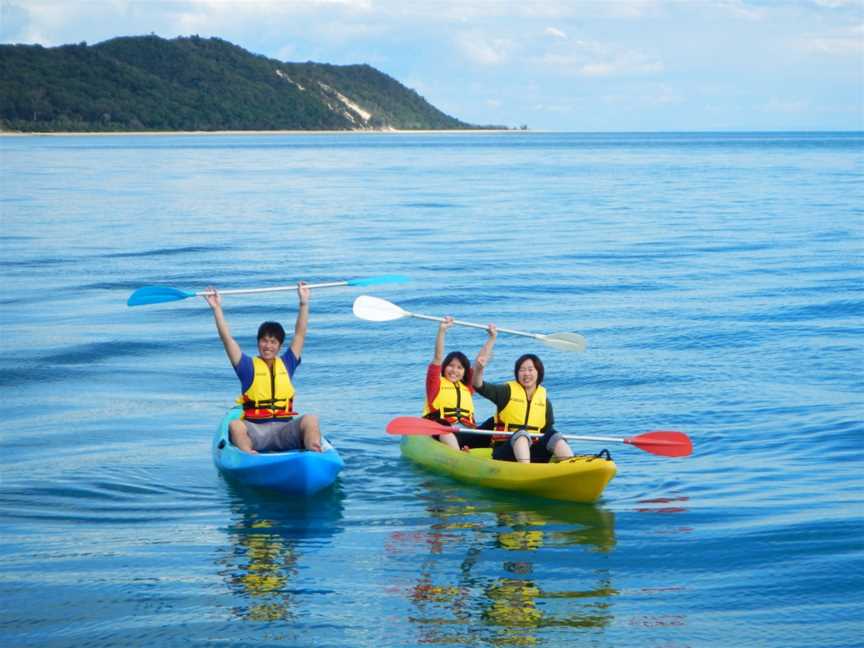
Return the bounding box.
[204,281,321,454]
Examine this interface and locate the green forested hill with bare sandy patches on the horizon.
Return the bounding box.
[0,35,505,132]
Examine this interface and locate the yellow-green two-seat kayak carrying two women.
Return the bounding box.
[401,435,616,503]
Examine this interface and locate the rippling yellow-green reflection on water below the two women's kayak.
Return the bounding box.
[402,486,618,645]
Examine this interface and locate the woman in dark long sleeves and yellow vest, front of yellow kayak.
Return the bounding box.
[472,340,573,463]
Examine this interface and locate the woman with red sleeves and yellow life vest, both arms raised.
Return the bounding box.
[423,317,497,450]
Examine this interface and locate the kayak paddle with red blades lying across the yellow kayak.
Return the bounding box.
[387,416,693,457]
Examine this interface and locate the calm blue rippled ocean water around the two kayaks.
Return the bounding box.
[0,133,864,647]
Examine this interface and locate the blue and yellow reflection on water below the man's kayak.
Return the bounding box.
[217,484,344,621]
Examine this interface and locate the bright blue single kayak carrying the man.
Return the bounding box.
[213,407,345,496]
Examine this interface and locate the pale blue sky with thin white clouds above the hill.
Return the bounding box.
[0,0,864,132]
